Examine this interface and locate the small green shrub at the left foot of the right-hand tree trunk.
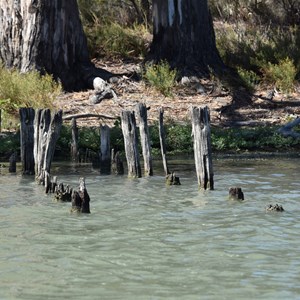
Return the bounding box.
[144,61,177,96]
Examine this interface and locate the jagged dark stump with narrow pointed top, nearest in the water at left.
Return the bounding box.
[71,177,90,214]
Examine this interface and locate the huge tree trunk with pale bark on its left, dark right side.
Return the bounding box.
[0,0,111,90]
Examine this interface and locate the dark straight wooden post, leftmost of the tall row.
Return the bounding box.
[19,108,35,175]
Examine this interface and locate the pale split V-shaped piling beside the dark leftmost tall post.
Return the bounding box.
[34,109,62,184]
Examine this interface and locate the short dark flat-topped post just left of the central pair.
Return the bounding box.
[100,125,111,174]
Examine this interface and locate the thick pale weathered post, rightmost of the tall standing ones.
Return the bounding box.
[191,106,214,190]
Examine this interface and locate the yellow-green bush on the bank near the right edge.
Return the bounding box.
[263,58,297,92]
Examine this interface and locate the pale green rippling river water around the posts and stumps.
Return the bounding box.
[0,158,300,300]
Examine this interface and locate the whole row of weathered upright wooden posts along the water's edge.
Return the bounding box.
[20,103,214,190]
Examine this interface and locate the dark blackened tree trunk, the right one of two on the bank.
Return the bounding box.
[149,0,224,76]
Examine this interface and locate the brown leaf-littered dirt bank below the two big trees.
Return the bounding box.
[54,61,300,127]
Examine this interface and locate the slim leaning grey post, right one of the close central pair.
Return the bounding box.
[136,103,153,176]
